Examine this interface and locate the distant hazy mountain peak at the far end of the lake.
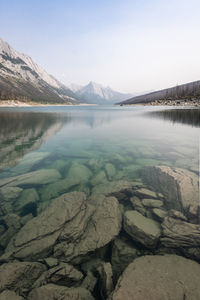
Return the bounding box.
[70,81,133,104]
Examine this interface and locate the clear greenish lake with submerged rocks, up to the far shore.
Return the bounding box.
[0,106,200,299]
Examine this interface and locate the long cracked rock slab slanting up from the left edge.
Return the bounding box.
[3,192,87,260]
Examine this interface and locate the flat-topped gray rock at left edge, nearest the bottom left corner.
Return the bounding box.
[0,262,46,291]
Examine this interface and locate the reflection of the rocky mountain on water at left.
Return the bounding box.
[0,112,70,169]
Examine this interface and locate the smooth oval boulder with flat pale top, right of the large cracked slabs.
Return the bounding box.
[124,210,161,248]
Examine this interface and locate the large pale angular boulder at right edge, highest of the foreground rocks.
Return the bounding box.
[144,166,200,223]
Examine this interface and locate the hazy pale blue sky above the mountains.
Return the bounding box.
[0,0,200,93]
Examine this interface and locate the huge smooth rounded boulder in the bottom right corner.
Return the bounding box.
[109,255,200,300]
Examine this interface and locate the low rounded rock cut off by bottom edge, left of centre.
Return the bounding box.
[27,284,94,300]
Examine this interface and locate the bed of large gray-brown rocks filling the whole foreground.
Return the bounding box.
[0,159,200,300]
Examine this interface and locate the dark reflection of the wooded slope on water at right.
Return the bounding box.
[149,108,200,127]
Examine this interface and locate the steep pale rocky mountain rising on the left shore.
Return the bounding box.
[0,38,77,103]
